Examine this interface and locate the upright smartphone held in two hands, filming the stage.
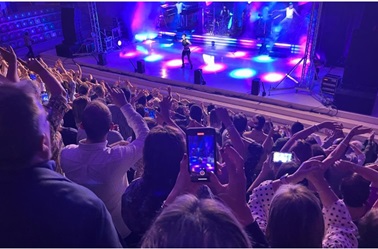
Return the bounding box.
[186,127,217,182]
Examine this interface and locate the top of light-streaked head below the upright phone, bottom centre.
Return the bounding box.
[142,195,251,248]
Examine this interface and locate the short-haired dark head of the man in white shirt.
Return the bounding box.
[82,100,112,143]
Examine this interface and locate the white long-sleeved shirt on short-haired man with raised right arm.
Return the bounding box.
[61,104,149,238]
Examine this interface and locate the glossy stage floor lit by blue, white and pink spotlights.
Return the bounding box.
[39,37,342,110]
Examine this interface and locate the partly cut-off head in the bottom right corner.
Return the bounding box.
[358,208,378,248]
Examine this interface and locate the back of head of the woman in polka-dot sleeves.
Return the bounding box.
[266,185,324,248]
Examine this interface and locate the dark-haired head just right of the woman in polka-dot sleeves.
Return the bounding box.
[340,173,370,207]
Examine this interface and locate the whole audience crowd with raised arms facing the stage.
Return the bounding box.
[0,47,378,248]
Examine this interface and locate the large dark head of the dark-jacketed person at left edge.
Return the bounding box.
[0,85,41,168]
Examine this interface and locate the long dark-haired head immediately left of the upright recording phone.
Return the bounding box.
[143,126,185,187]
